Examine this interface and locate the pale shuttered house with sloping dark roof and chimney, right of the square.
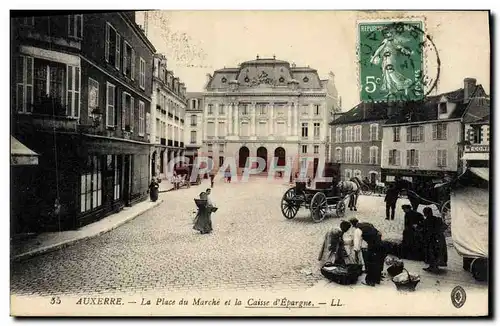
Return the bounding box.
[381,78,485,182]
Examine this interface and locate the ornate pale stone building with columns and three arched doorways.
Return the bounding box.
[202,56,338,175]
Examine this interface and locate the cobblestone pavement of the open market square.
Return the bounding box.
[11,178,480,295]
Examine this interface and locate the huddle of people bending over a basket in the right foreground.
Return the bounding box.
[318,218,388,286]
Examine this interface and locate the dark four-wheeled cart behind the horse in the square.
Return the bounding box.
[281,182,348,223]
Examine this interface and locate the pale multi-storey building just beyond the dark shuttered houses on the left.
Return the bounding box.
[150,53,187,178]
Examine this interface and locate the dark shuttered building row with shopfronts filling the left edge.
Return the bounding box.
[11,12,155,232]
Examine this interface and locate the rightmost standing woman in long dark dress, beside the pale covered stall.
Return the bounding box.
[422,207,448,273]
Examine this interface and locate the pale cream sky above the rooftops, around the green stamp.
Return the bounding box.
[137,11,490,111]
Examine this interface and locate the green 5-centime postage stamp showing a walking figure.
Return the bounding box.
[358,21,425,102]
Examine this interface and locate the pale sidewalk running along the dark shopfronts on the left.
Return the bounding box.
[10,199,163,261]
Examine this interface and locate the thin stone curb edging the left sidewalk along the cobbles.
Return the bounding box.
[10,199,163,262]
